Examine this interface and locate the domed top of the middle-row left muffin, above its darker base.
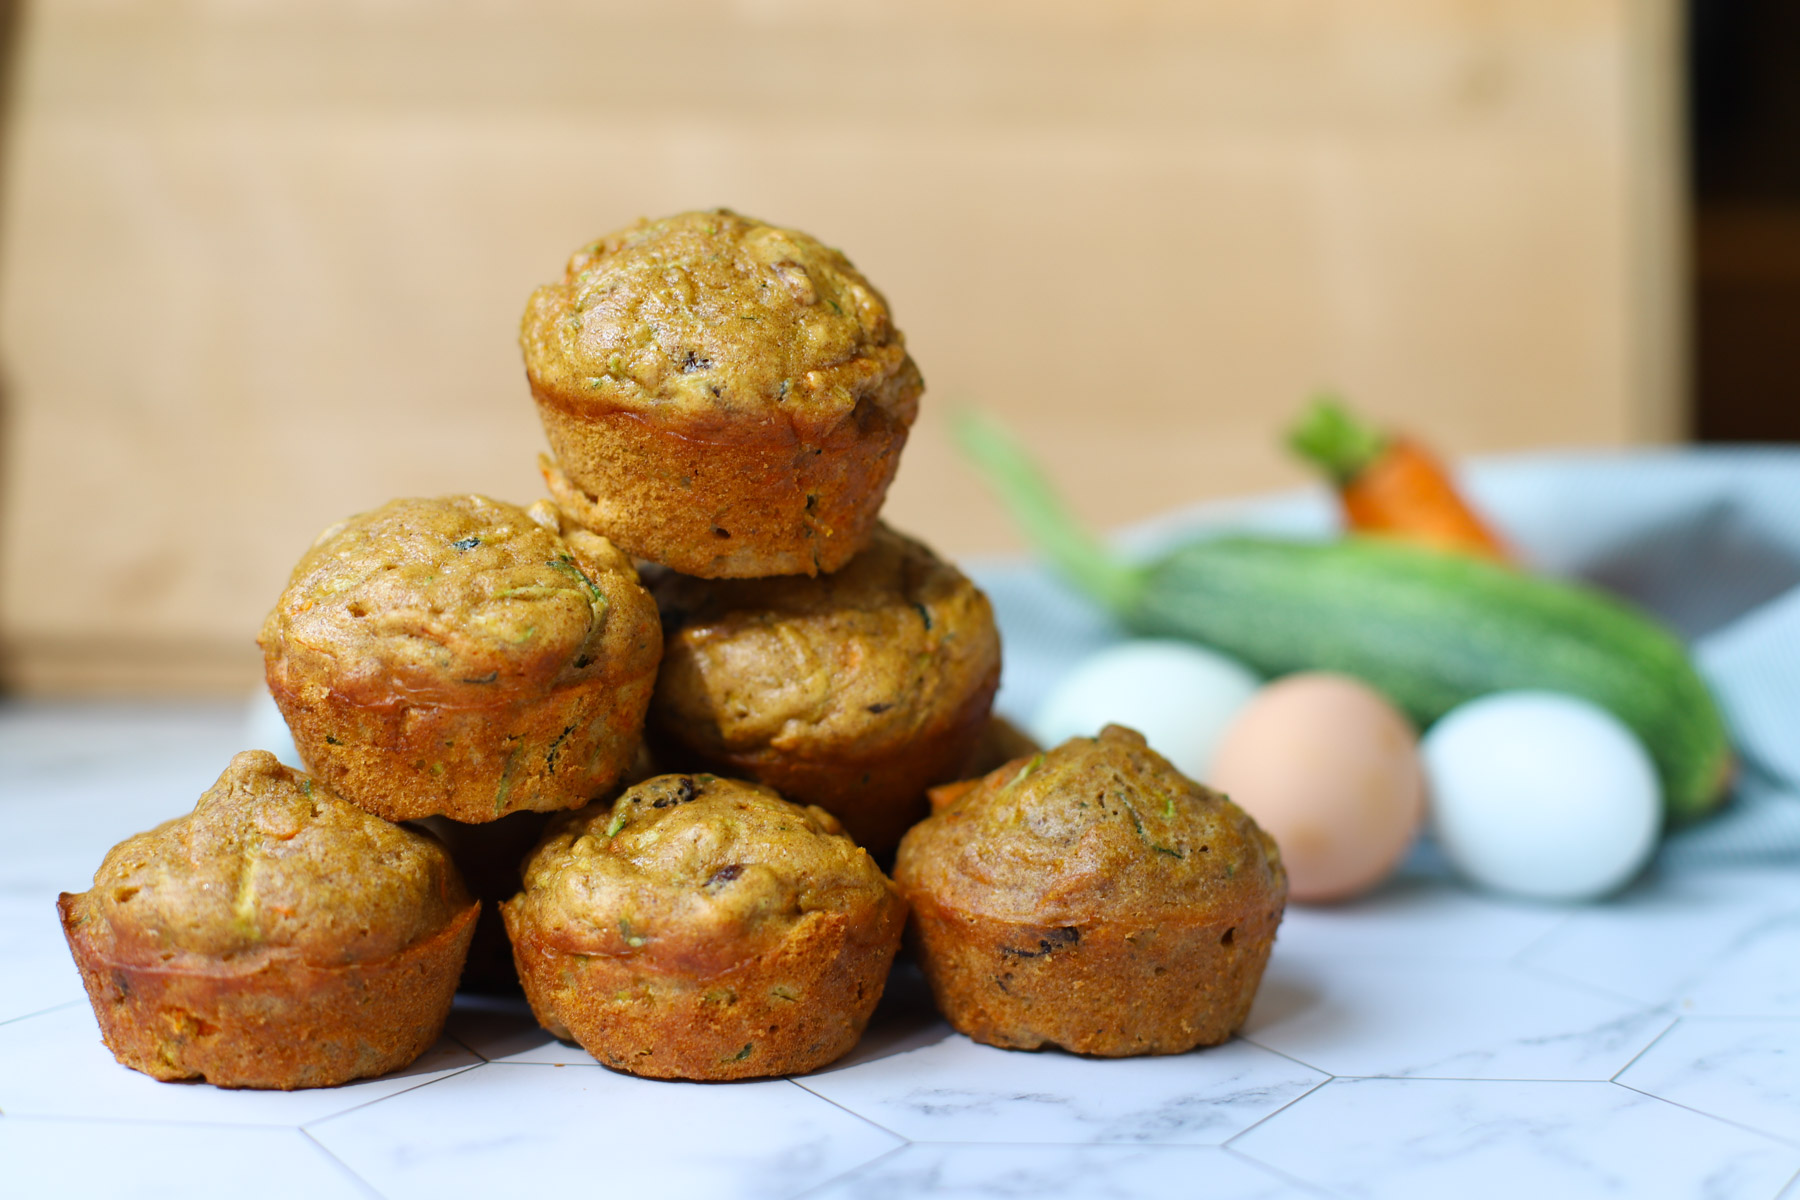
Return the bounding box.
[257,495,662,707]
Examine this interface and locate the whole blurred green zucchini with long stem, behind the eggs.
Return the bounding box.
[958,416,1733,822]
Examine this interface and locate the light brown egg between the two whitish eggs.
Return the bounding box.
[1208,673,1426,901]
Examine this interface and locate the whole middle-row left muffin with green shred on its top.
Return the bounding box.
[257,497,662,822]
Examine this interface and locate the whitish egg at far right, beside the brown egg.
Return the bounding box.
[1420,691,1661,900]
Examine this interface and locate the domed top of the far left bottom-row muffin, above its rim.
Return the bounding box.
[76,750,470,966]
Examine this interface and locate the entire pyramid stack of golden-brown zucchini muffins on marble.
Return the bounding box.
[61,210,1285,1087]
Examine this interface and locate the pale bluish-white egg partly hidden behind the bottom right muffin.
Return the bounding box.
[1031,639,1260,779]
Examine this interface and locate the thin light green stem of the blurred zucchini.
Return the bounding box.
[950,408,1143,613]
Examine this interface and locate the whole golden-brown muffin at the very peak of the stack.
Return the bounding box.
[520,209,923,578]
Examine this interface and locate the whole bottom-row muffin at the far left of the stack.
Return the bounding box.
[56,750,477,1088]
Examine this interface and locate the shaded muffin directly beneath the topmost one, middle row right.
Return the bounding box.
[650,525,1001,858]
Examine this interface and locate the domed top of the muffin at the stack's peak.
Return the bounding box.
[518,209,923,437]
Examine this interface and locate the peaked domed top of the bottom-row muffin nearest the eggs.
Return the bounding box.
[895,725,1287,925]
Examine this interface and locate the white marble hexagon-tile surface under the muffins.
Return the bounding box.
[0,705,1800,1200]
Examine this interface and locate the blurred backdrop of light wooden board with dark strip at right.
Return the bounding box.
[0,0,1800,694]
